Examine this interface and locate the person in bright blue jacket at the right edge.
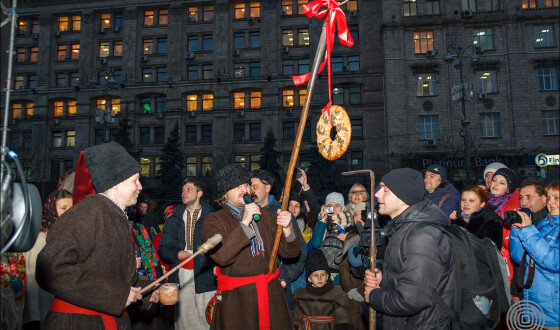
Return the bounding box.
[510,181,560,329]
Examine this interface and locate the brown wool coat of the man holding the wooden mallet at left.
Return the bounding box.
[37,194,149,330]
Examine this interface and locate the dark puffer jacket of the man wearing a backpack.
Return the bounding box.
[369,199,457,330]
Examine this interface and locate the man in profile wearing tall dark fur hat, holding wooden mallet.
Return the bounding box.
[37,142,159,330]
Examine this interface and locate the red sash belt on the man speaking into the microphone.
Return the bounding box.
[216,267,280,330]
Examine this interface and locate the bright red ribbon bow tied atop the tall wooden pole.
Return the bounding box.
[292,0,354,121]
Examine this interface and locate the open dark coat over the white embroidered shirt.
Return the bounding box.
[158,202,216,293]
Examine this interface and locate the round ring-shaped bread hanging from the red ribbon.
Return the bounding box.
[317,105,352,161]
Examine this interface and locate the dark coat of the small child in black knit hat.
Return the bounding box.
[292,280,353,330]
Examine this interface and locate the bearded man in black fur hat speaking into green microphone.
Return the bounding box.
[202,164,300,330]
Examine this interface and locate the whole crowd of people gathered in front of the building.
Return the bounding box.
[0,143,560,329]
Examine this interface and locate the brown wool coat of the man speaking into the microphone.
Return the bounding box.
[202,207,301,330]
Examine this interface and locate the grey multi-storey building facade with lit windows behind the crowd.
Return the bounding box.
[0,0,560,191]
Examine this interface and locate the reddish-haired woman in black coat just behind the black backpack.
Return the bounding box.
[449,186,503,250]
